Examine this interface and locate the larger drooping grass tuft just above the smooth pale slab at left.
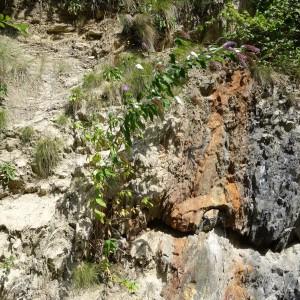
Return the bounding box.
[34,137,61,178]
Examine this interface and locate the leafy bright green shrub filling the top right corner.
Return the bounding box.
[221,0,300,77]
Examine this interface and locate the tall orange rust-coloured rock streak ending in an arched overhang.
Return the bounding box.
[166,70,252,232]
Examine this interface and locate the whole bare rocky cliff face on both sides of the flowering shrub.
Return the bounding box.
[0,1,300,300]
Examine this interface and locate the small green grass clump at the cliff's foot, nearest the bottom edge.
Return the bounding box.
[73,263,99,289]
